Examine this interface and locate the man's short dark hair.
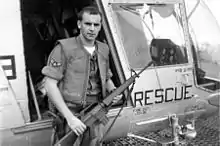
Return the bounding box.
[78,6,102,21]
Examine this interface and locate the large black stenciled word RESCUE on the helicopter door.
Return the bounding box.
[133,85,192,107]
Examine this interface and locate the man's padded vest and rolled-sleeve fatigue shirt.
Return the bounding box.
[43,36,112,104]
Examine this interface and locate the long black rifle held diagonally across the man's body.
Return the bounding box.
[55,61,153,146]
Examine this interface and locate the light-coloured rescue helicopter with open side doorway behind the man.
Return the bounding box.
[0,0,220,146]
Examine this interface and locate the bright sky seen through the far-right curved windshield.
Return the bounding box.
[186,0,220,45]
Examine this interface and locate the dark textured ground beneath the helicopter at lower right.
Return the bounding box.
[104,112,220,146]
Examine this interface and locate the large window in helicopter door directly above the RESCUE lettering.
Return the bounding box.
[112,4,188,68]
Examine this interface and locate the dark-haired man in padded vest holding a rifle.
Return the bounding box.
[42,6,122,146]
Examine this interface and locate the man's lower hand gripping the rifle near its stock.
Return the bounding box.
[67,116,86,136]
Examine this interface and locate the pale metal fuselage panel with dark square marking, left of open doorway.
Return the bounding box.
[0,0,30,122]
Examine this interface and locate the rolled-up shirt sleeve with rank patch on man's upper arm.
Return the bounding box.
[42,44,65,80]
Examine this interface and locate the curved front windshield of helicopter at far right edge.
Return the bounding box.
[185,0,220,91]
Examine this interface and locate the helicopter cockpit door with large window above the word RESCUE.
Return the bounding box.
[106,0,196,132]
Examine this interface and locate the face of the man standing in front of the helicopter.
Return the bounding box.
[78,12,101,41]
